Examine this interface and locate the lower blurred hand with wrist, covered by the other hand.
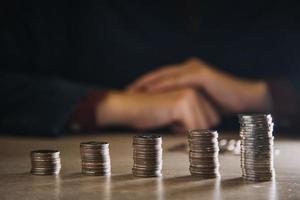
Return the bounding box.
[96,89,219,130]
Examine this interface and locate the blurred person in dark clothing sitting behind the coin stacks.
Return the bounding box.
[0,0,300,135]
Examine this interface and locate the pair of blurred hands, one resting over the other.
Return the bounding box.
[96,58,271,131]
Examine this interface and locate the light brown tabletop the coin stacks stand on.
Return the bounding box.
[0,134,300,200]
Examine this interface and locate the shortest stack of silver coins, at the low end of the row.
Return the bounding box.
[30,150,61,175]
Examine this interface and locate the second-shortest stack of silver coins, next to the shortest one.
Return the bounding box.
[80,141,111,176]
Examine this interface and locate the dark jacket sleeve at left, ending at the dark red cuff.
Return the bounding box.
[0,73,90,136]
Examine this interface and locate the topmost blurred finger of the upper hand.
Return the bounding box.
[128,65,179,90]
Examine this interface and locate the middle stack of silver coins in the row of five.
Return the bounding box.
[132,135,162,177]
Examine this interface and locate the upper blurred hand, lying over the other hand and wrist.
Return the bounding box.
[128,58,271,113]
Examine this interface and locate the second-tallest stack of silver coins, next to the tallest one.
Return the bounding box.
[188,130,220,178]
